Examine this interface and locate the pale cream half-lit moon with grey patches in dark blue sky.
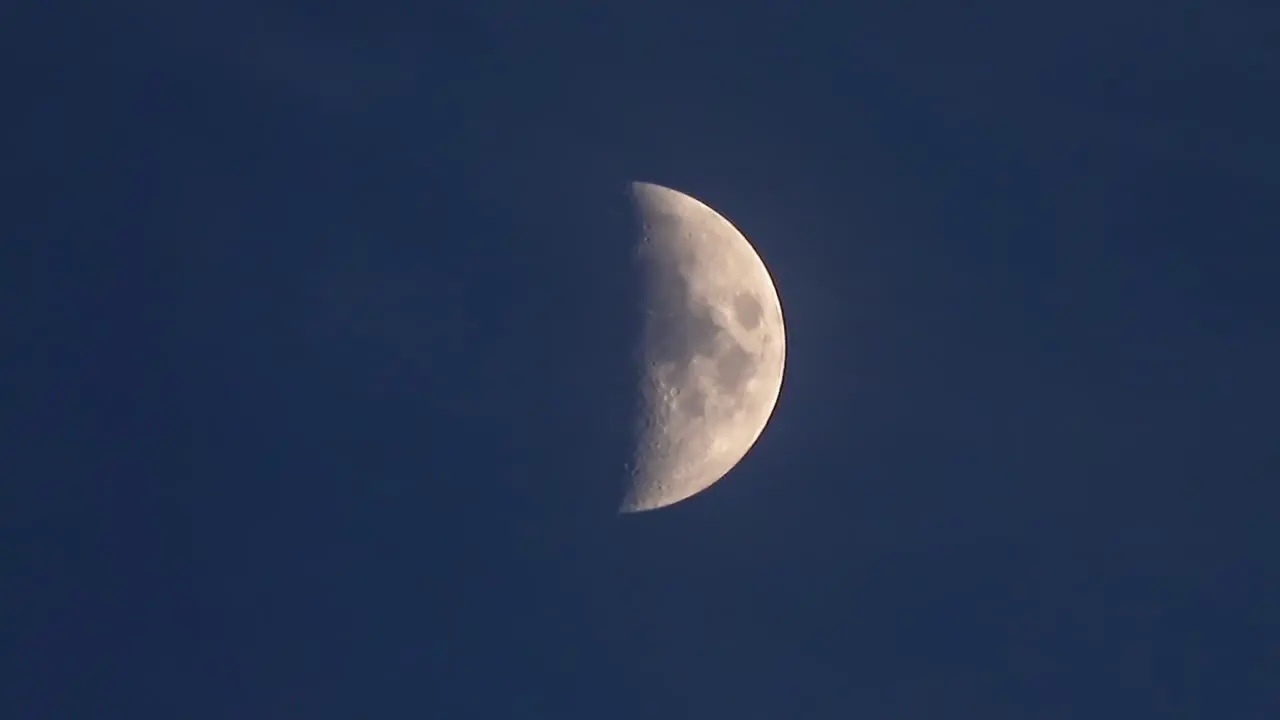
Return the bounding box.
[618,182,786,512]
